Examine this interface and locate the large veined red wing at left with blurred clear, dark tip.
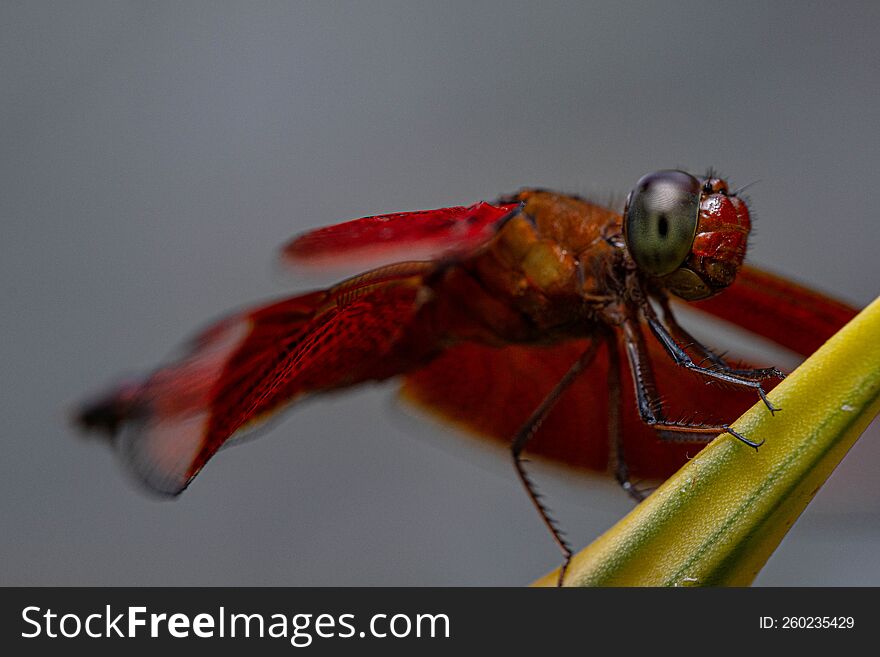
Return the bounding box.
[79,267,432,495]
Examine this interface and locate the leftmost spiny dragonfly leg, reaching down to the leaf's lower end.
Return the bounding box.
[510,340,602,586]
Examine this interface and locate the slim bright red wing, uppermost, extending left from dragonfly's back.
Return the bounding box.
[282,202,520,266]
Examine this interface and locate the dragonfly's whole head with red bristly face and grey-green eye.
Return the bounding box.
[623,170,751,301]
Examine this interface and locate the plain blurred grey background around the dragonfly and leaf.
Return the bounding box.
[0,1,880,585]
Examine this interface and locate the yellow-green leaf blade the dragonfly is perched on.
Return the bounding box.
[535,299,880,586]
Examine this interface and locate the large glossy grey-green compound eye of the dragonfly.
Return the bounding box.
[623,170,700,276]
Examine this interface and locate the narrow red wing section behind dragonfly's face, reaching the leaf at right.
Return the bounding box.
[689,267,858,356]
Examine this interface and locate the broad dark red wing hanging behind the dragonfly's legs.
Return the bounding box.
[402,339,772,479]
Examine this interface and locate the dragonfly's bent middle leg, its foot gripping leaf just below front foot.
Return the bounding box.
[623,318,763,450]
